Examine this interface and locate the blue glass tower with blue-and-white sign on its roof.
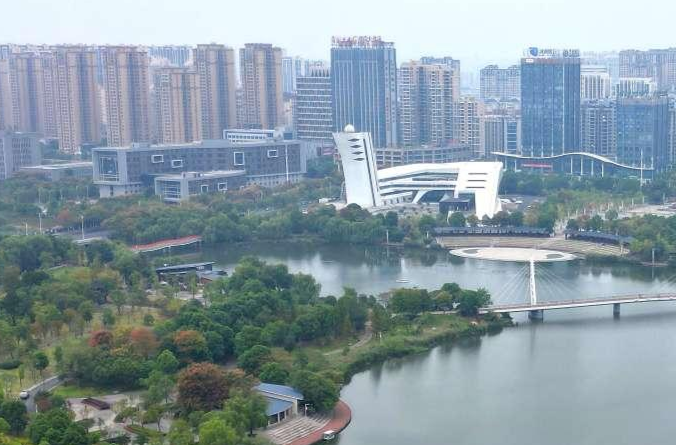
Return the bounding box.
[521,48,580,156]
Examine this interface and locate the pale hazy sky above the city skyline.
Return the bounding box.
[0,0,676,69]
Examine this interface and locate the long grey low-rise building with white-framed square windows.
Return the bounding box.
[92,139,314,198]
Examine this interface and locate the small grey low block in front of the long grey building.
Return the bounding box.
[155,170,246,203]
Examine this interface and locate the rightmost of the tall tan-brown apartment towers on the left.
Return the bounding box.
[239,43,284,129]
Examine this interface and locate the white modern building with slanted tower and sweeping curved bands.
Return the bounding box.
[333,125,502,218]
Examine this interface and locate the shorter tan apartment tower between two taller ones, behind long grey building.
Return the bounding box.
[153,68,202,144]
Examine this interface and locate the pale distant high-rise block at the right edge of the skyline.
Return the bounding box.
[620,48,676,91]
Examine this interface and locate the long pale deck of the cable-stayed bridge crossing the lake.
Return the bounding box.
[479,293,676,314]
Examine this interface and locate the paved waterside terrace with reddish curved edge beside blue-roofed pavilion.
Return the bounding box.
[265,400,352,445]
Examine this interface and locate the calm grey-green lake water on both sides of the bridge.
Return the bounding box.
[201,244,676,445]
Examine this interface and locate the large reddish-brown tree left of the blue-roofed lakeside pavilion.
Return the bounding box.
[178,363,228,411]
